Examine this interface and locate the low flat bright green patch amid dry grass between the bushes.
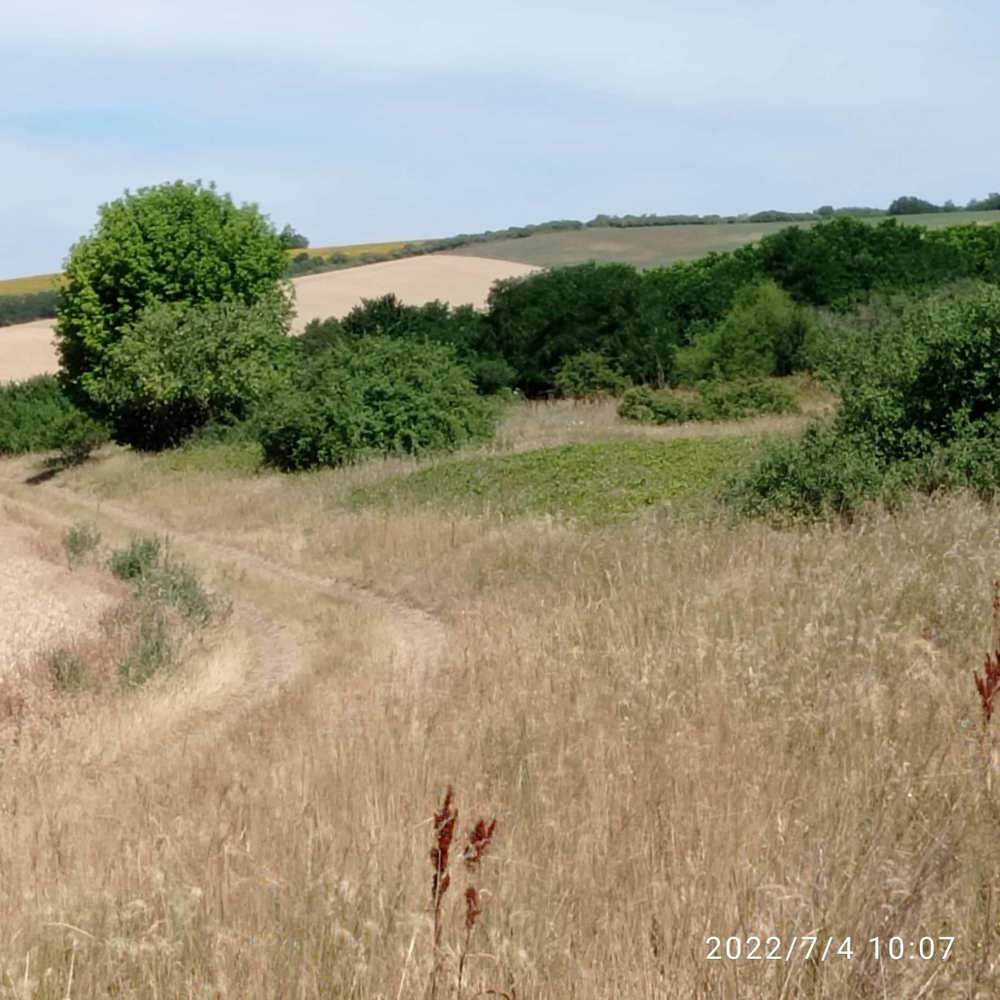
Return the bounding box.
[352,437,759,523]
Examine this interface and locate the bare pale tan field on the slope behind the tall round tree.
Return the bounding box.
[0,255,537,382]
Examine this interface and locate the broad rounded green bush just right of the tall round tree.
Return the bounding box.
[260,336,489,471]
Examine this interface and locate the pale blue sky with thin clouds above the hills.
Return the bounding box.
[0,0,1000,277]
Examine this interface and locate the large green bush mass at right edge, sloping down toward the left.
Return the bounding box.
[730,285,1000,517]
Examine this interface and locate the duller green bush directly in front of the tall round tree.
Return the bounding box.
[92,300,295,450]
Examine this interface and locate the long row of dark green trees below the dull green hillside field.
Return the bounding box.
[302,217,1000,396]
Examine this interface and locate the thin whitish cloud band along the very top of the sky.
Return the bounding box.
[4,0,996,107]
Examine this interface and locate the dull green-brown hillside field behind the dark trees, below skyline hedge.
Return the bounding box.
[449,212,1000,267]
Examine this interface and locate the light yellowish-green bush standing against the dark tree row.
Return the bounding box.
[677,281,814,382]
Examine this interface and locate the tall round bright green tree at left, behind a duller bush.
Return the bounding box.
[57,181,290,422]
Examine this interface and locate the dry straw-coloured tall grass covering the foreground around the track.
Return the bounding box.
[0,405,1000,1000]
